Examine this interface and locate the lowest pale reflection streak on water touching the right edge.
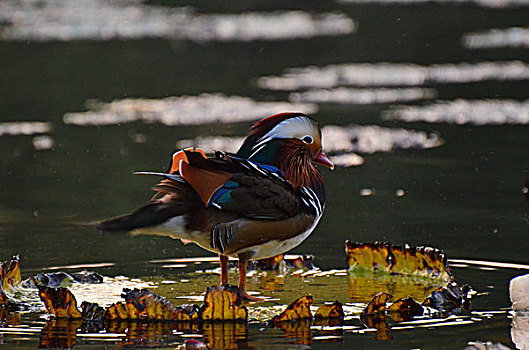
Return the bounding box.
[385,99,529,125]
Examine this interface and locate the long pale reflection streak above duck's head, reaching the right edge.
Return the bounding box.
[257,61,529,91]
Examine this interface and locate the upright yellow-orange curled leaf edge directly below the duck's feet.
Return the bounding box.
[200,286,248,321]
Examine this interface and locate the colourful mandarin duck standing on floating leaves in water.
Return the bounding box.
[97,113,334,300]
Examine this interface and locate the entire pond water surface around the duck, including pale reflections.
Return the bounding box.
[0,0,529,349]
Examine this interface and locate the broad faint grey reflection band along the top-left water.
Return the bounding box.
[0,0,355,42]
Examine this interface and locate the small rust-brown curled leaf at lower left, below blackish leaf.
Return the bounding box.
[39,287,82,319]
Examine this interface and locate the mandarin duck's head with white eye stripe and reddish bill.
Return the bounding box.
[237,113,334,170]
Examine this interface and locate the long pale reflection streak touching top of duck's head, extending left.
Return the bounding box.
[63,94,318,126]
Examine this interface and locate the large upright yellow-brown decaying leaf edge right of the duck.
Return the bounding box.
[345,241,452,282]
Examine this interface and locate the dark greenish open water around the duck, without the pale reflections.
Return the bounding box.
[0,2,529,349]
